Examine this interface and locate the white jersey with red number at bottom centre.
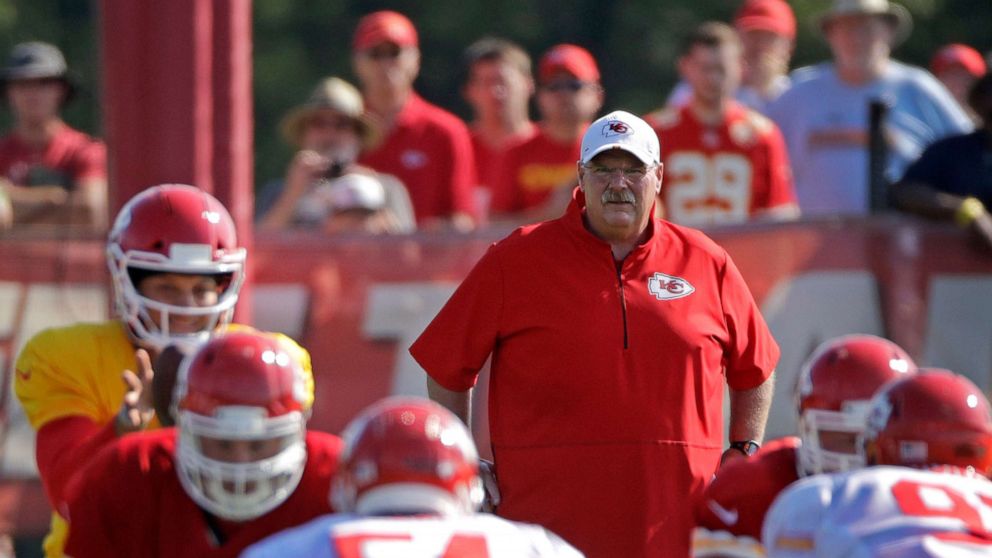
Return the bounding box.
[241,514,582,558]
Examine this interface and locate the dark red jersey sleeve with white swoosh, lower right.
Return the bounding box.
[695,436,802,540]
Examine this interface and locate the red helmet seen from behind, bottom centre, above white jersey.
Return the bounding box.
[331,397,483,514]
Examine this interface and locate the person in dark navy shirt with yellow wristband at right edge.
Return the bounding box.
[890,74,992,252]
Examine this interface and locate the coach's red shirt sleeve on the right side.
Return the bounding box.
[720,253,779,390]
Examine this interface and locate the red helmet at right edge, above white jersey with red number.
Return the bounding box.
[862,369,992,475]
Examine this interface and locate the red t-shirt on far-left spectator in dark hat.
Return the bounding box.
[0,124,107,190]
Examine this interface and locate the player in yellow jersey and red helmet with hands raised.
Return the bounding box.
[14,184,313,557]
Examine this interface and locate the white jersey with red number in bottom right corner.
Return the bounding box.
[762,467,992,558]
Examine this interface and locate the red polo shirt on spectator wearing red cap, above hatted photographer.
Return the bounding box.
[360,94,476,224]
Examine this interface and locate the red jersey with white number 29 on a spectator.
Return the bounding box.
[645,103,796,226]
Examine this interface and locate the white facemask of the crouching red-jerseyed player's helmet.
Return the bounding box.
[176,406,307,521]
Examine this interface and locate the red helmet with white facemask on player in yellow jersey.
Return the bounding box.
[107,184,245,350]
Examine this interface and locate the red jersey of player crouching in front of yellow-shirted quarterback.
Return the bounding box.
[66,428,342,558]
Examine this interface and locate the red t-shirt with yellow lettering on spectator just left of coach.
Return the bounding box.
[490,130,582,213]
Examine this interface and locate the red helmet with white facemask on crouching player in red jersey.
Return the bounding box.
[176,331,309,521]
